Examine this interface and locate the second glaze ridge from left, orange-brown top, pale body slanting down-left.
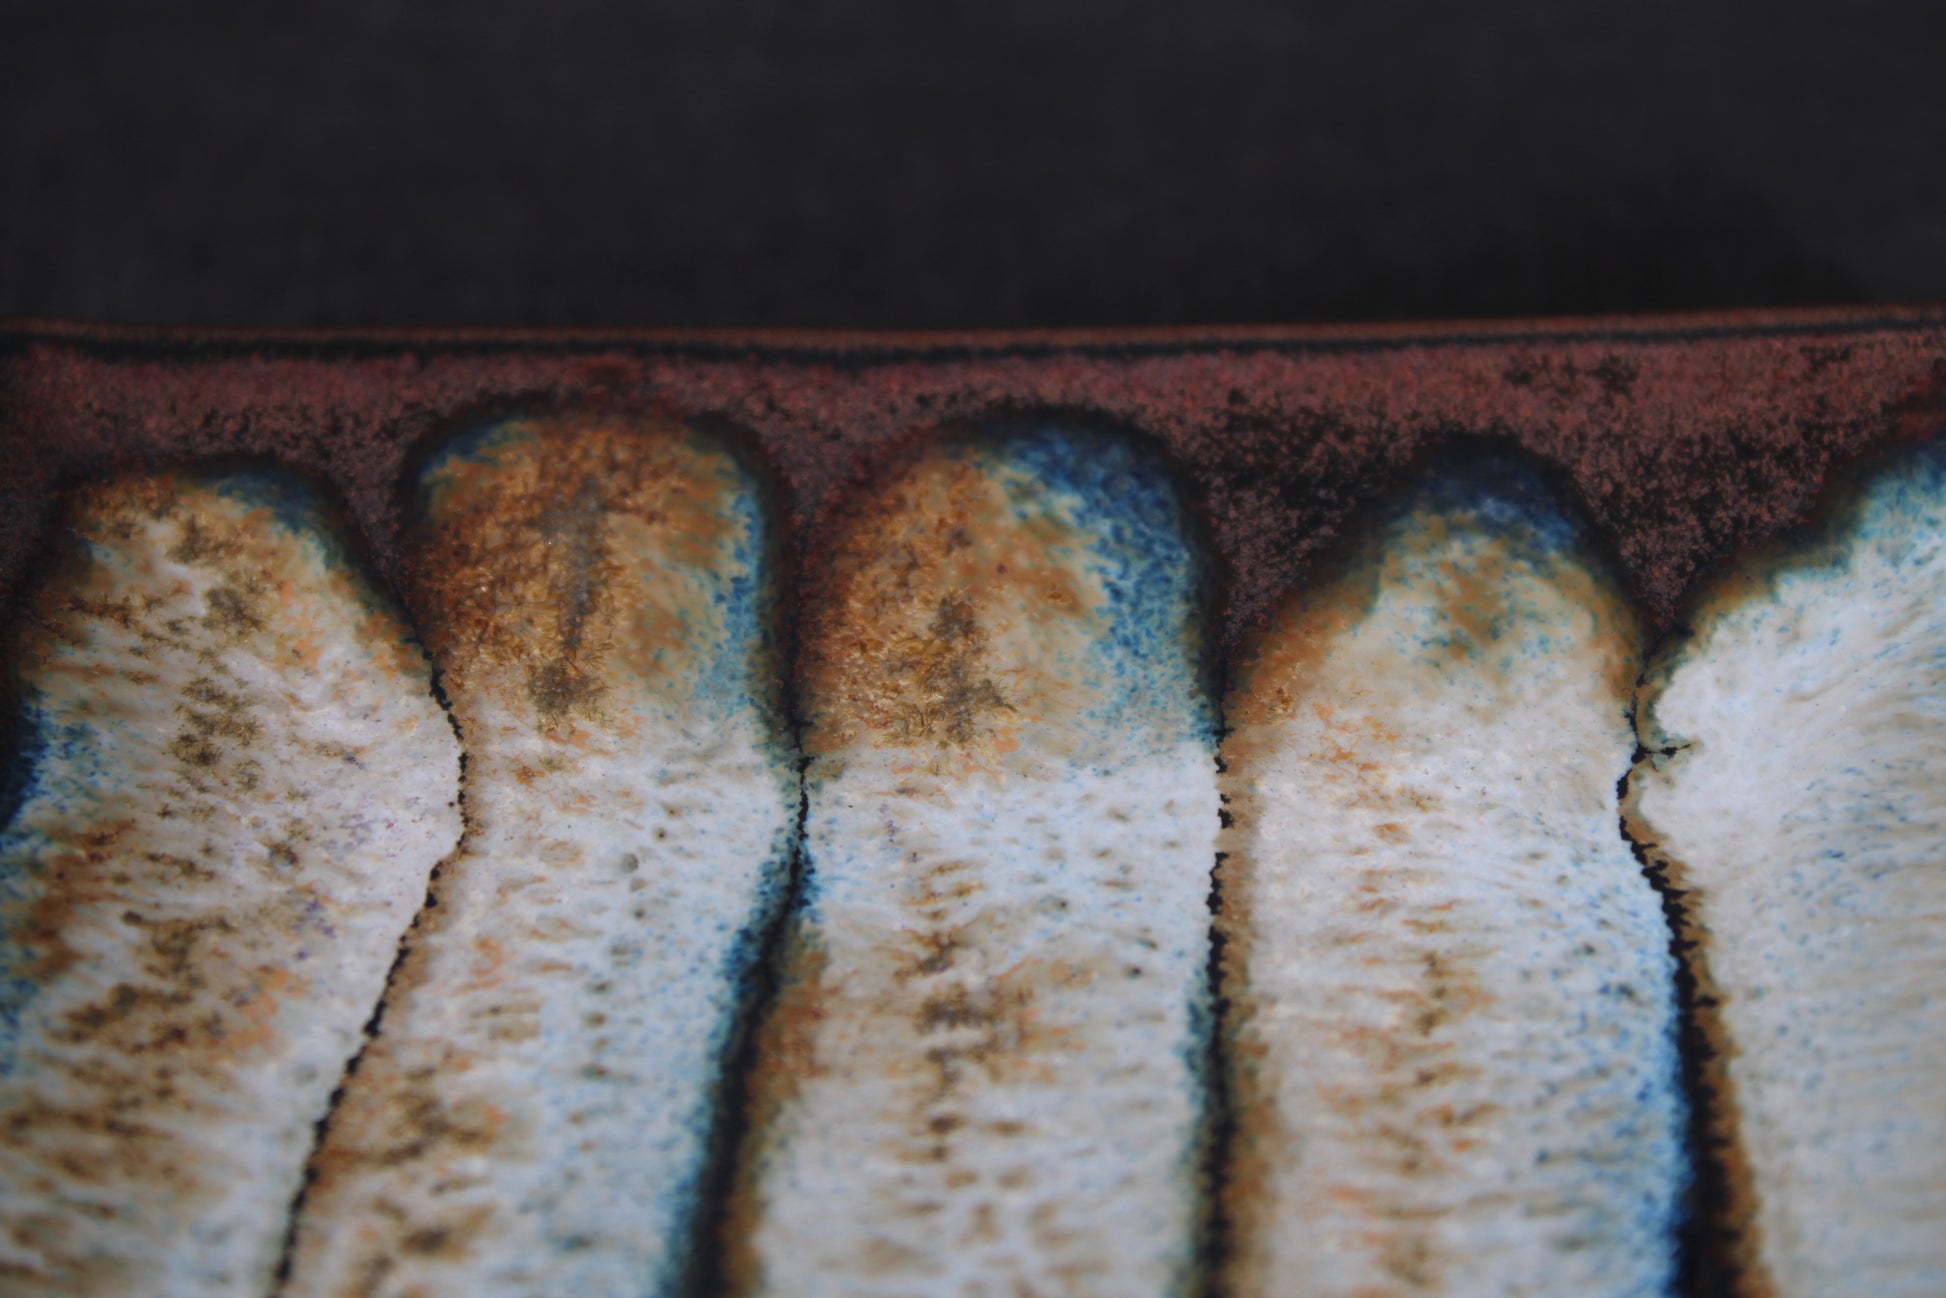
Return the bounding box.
[286,416,798,1298]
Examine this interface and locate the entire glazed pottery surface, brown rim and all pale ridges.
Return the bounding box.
[0,311,1946,1298]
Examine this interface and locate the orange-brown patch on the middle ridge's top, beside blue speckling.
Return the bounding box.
[804,446,1175,765]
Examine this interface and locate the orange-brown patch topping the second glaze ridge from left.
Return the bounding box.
[413,418,747,730]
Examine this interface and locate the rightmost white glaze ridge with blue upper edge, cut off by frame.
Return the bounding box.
[1629,446,1946,1298]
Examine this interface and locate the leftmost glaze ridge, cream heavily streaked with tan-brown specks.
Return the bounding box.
[0,475,459,1296]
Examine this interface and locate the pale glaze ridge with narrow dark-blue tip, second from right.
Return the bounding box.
[1218,465,1687,1298]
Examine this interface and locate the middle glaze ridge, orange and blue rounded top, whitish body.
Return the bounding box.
[728,428,1216,1298]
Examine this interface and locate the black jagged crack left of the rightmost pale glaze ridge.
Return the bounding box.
[1615,673,1742,1298]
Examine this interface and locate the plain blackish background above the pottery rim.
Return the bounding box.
[0,0,1946,327]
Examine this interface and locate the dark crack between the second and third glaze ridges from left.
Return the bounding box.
[669,739,811,1298]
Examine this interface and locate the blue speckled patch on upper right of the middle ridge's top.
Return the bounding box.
[979,422,1216,745]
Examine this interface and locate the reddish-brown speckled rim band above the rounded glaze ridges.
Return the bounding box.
[0,307,1946,644]
